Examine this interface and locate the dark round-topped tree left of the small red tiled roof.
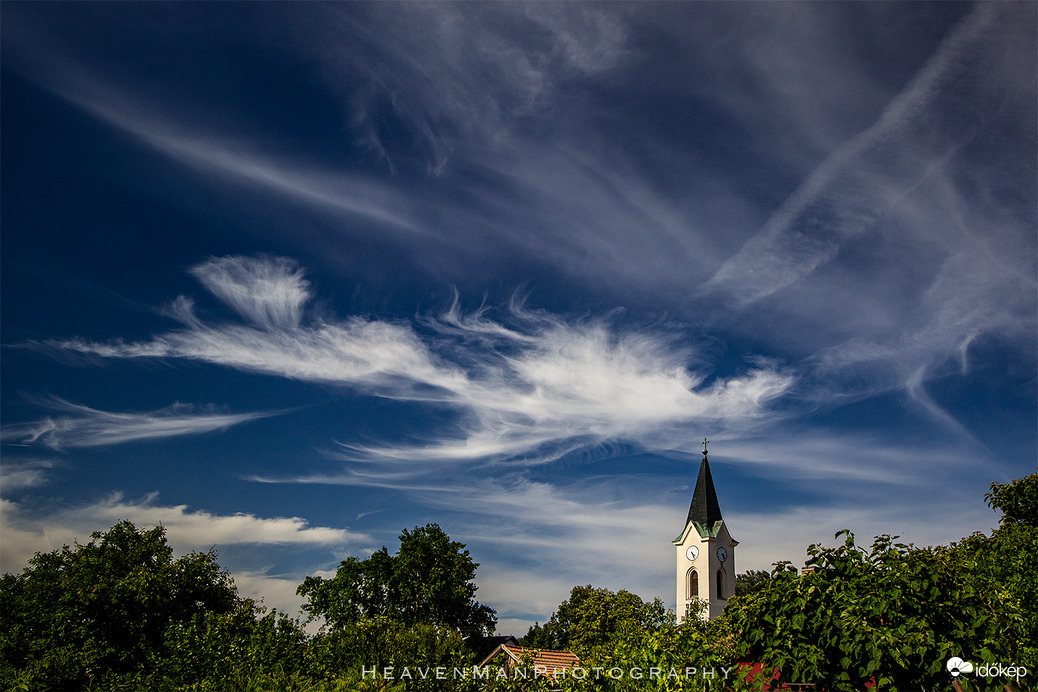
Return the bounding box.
[297,524,497,634]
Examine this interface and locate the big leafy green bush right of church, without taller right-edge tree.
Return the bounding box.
[726,531,1008,690]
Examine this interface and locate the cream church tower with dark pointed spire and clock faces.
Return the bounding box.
[672,439,739,622]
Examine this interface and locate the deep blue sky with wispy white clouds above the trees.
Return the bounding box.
[0,1,1038,635]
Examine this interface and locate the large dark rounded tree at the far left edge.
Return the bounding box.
[0,522,239,689]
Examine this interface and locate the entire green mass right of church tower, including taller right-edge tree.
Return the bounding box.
[721,474,1038,690]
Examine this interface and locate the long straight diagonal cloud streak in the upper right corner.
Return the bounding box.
[703,5,1025,304]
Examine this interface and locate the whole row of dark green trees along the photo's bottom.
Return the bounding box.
[0,473,1038,692]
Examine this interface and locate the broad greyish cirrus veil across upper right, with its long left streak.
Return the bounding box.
[16,5,1034,410]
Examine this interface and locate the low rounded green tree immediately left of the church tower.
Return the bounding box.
[522,584,674,654]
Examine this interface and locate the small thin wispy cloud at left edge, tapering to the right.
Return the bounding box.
[0,397,275,449]
